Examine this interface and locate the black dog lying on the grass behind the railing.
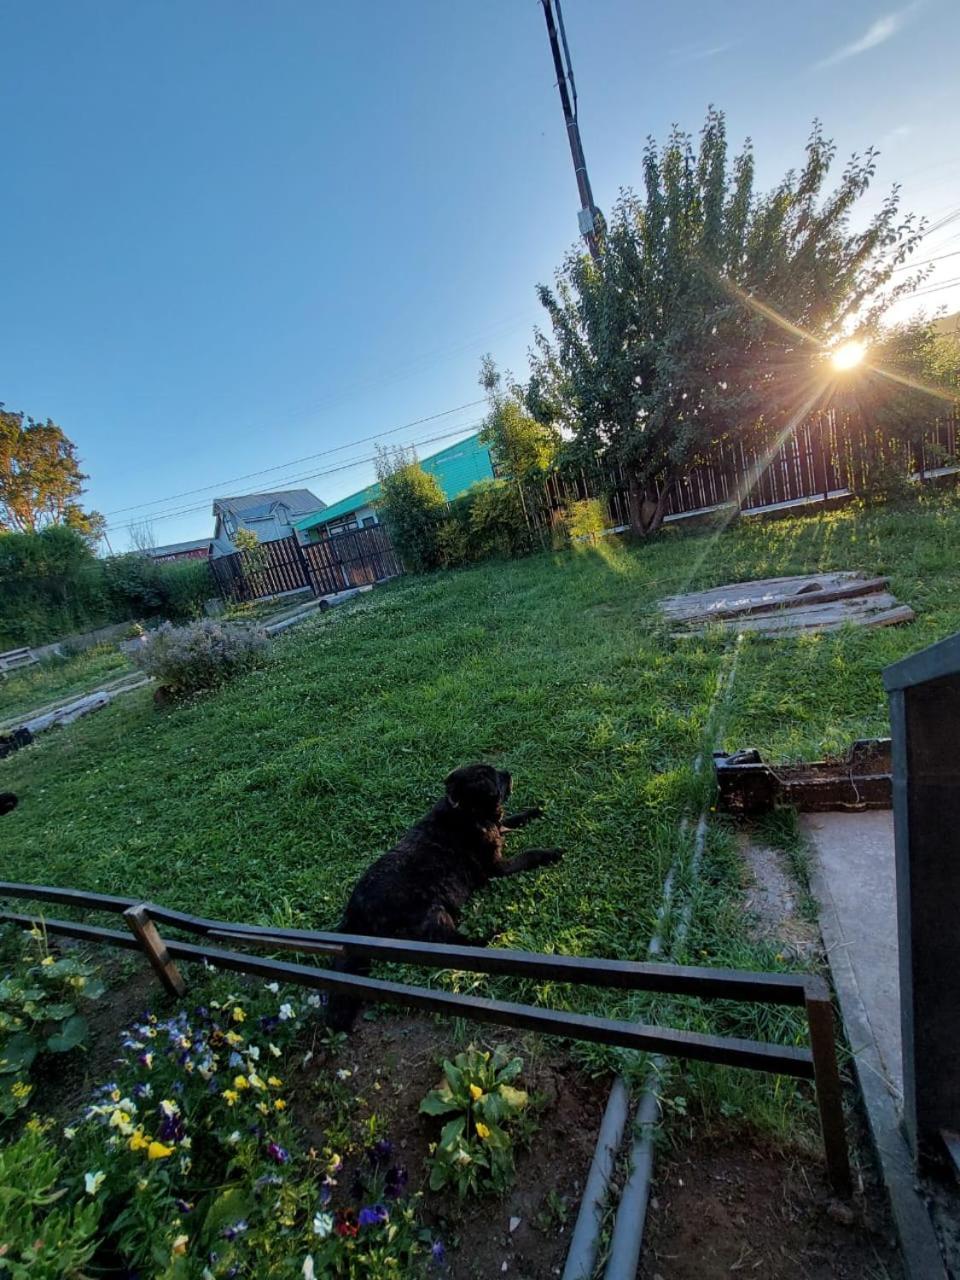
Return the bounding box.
[326,764,562,1030]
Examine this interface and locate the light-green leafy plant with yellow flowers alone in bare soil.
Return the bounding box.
[420,1046,530,1199]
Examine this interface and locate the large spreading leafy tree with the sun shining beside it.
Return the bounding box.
[527,110,919,532]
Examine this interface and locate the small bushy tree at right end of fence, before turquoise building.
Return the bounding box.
[376,448,447,573]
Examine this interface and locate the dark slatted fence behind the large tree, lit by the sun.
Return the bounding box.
[535,411,960,525]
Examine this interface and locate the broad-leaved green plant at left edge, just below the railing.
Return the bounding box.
[0,929,106,1119]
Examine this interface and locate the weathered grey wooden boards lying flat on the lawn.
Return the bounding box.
[660,571,914,635]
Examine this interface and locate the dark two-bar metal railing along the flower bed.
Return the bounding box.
[0,881,850,1196]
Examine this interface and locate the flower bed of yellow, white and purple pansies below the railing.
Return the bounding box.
[0,938,611,1280]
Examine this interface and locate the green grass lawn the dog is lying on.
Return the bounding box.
[0,498,960,1123]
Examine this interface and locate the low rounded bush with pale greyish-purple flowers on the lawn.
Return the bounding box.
[133,618,266,696]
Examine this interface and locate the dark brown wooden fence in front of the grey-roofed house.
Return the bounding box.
[210,525,403,602]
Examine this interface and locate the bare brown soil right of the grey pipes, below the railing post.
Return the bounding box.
[639,1142,904,1280]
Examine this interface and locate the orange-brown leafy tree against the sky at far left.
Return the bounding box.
[0,404,105,539]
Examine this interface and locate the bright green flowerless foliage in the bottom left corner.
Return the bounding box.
[0,1120,100,1280]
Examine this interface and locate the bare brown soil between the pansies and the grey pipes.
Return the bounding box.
[294,1016,609,1280]
